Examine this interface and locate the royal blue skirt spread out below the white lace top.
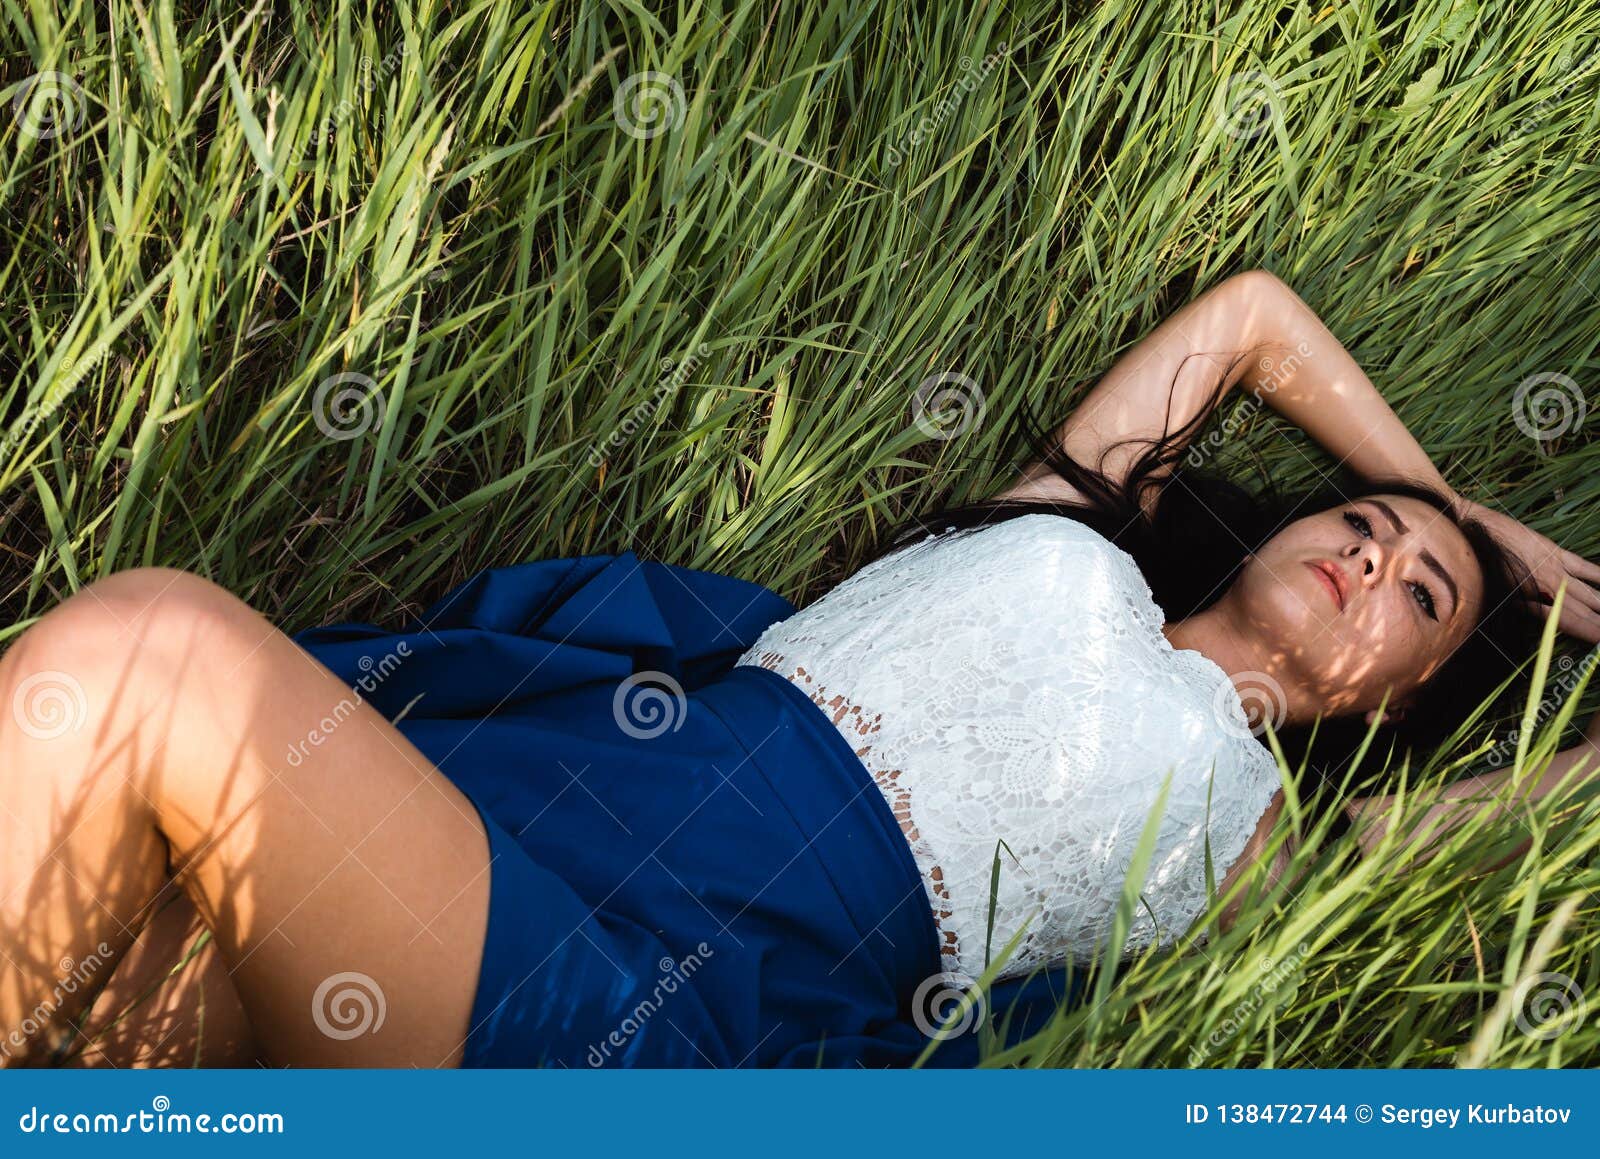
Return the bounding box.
[296,552,1082,1066]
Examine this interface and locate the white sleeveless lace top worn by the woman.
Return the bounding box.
[738,515,1280,986]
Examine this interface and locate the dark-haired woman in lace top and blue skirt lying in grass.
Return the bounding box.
[0,272,1600,1066]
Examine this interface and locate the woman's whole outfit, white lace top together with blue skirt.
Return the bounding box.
[298,515,1280,1066]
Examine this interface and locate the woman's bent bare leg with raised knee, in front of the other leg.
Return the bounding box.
[0,568,488,1066]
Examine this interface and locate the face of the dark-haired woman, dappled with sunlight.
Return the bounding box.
[1230,495,1483,714]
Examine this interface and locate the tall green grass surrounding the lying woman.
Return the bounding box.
[9,0,1600,1066]
